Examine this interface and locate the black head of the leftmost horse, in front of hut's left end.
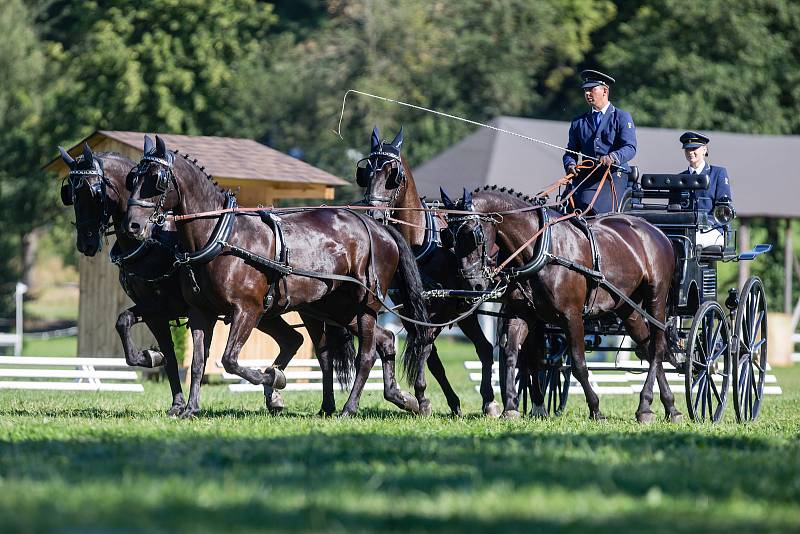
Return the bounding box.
[58,144,114,256]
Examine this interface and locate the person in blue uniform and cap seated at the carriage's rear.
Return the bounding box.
[680,132,733,247]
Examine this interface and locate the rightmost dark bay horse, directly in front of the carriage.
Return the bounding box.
[443,189,681,423]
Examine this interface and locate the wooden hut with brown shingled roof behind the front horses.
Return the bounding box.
[45,130,347,372]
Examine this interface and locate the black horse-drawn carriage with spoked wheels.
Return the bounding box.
[510,171,771,422]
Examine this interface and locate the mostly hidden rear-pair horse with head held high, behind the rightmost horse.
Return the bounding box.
[356,126,500,417]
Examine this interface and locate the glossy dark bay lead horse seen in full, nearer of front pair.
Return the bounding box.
[125,136,429,415]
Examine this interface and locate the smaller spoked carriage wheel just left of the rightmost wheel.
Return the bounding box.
[685,301,733,423]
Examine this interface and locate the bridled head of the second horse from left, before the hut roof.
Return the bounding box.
[123,136,180,240]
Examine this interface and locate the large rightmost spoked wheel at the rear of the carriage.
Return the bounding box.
[733,276,767,423]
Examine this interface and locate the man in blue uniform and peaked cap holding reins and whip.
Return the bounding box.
[563,70,636,214]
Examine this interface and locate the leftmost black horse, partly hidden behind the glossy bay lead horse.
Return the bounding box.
[60,142,322,416]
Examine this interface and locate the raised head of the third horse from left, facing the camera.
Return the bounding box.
[356,126,406,220]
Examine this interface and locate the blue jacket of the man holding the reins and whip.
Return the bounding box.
[563,104,636,172]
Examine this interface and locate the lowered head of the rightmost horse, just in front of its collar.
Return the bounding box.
[441,189,498,291]
